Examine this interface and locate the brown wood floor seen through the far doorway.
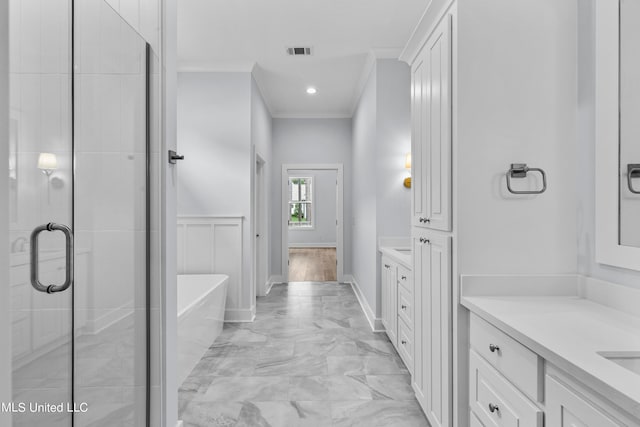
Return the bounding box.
[289,248,338,282]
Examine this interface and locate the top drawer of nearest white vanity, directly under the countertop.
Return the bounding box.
[470,313,544,402]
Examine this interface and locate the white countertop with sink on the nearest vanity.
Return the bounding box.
[461,293,640,417]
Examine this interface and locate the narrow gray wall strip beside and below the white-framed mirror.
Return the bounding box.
[577,0,640,288]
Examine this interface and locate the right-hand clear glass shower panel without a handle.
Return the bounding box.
[74,0,149,427]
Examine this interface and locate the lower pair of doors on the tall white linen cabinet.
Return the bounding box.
[413,231,452,427]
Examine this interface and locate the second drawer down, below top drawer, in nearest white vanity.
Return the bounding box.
[469,350,543,427]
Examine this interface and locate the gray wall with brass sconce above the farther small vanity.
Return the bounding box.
[353,59,411,317]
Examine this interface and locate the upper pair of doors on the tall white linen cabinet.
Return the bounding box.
[411,15,452,231]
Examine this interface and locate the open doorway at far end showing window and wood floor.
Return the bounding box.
[282,164,344,282]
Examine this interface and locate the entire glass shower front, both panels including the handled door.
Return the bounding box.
[9,0,151,427]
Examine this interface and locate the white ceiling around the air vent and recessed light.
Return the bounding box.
[178,0,430,117]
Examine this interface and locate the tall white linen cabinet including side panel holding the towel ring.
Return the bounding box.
[400,0,577,427]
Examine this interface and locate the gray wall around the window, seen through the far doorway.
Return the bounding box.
[289,170,338,247]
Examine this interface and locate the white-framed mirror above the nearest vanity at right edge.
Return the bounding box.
[593,0,640,271]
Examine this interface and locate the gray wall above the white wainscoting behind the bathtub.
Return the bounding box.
[178,73,252,217]
